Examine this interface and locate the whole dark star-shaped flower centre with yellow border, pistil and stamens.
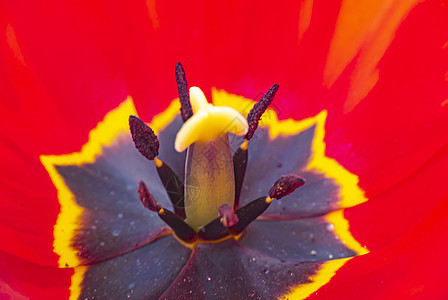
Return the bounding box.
[41,64,367,299]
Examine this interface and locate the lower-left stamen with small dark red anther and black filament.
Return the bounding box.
[138,180,197,243]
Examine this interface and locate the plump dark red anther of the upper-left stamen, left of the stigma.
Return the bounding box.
[129,116,159,160]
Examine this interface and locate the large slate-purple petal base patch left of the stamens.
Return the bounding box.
[56,135,171,264]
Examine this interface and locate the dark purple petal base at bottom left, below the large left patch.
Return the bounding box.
[79,236,191,299]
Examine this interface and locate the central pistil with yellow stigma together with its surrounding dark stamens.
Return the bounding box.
[129,63,305,243]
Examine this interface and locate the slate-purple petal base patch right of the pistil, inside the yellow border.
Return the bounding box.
[240,127,339,218]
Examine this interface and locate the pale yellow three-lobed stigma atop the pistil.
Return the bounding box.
[174,87,249,152]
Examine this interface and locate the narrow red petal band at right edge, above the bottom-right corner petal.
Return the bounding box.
[345,140,448,250]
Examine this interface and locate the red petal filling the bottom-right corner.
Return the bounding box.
[310,196,448,299]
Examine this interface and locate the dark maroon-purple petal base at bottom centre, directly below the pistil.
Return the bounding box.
[161,240,321,299]
